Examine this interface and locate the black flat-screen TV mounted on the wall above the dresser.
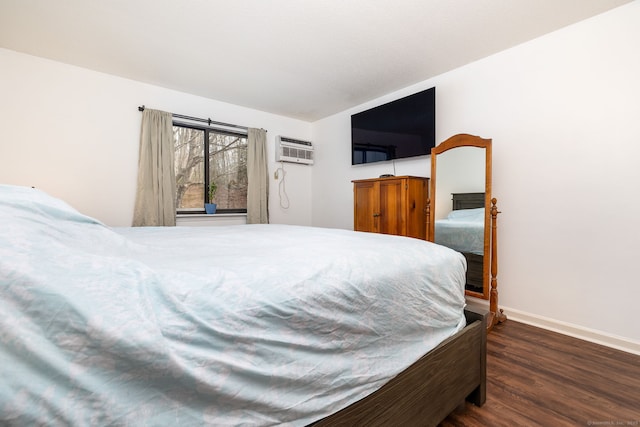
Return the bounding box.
[351,87,436,165]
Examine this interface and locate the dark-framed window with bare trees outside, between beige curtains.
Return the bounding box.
[173,122,247,213]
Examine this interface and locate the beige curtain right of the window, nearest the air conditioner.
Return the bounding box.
[247,128,269,224]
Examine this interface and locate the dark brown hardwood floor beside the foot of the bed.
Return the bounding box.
[441,320,640,427]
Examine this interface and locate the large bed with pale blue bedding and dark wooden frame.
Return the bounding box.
[0,186,486,426]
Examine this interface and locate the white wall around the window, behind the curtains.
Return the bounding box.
[0,49,312,226]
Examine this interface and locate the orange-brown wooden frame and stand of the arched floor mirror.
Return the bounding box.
[427,134,506,329]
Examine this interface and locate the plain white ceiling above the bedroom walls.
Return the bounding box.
[0,0,631,121]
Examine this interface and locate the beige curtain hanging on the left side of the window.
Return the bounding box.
[133,109,176,227]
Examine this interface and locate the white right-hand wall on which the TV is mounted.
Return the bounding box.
[313,2,640,348]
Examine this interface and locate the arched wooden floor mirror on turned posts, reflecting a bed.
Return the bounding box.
[427,134,506,329]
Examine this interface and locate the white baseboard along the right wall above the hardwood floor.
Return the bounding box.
[470,298,640,356]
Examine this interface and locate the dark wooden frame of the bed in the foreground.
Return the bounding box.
[312,307,488,427]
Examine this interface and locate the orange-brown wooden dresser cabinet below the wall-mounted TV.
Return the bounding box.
[352,176,429,239]
